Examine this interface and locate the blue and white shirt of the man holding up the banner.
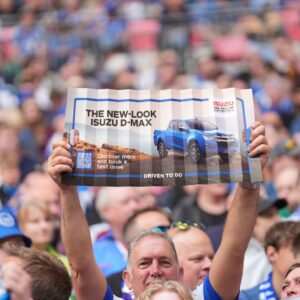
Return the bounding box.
[103,276,222,300]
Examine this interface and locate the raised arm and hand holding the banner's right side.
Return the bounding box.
[209,122,270,300]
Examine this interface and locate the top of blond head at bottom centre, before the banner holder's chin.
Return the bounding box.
[138,280,193,300]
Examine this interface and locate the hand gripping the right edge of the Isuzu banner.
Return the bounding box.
[248,121,270,168]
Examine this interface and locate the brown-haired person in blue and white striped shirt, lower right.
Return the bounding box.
[239,221,300,300]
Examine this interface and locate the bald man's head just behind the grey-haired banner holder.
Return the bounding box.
[171,227,214,290]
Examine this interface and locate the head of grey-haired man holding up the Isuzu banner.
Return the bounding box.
[123,236,180,297]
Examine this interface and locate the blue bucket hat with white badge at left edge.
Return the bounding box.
[0,208,32,247]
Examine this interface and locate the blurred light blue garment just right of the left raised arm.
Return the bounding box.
[93,231,127,277]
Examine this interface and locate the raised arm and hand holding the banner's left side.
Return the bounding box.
[48,141,107,300]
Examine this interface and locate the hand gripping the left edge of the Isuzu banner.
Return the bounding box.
[48,141,73,186]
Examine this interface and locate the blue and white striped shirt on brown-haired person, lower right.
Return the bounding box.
[239,272,279,300]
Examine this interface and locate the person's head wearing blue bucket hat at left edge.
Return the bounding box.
[0,208,31,248]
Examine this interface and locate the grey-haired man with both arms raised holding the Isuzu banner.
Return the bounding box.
[48,122,270,300]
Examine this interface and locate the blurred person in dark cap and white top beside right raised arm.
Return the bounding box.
[241,197,287,290]
